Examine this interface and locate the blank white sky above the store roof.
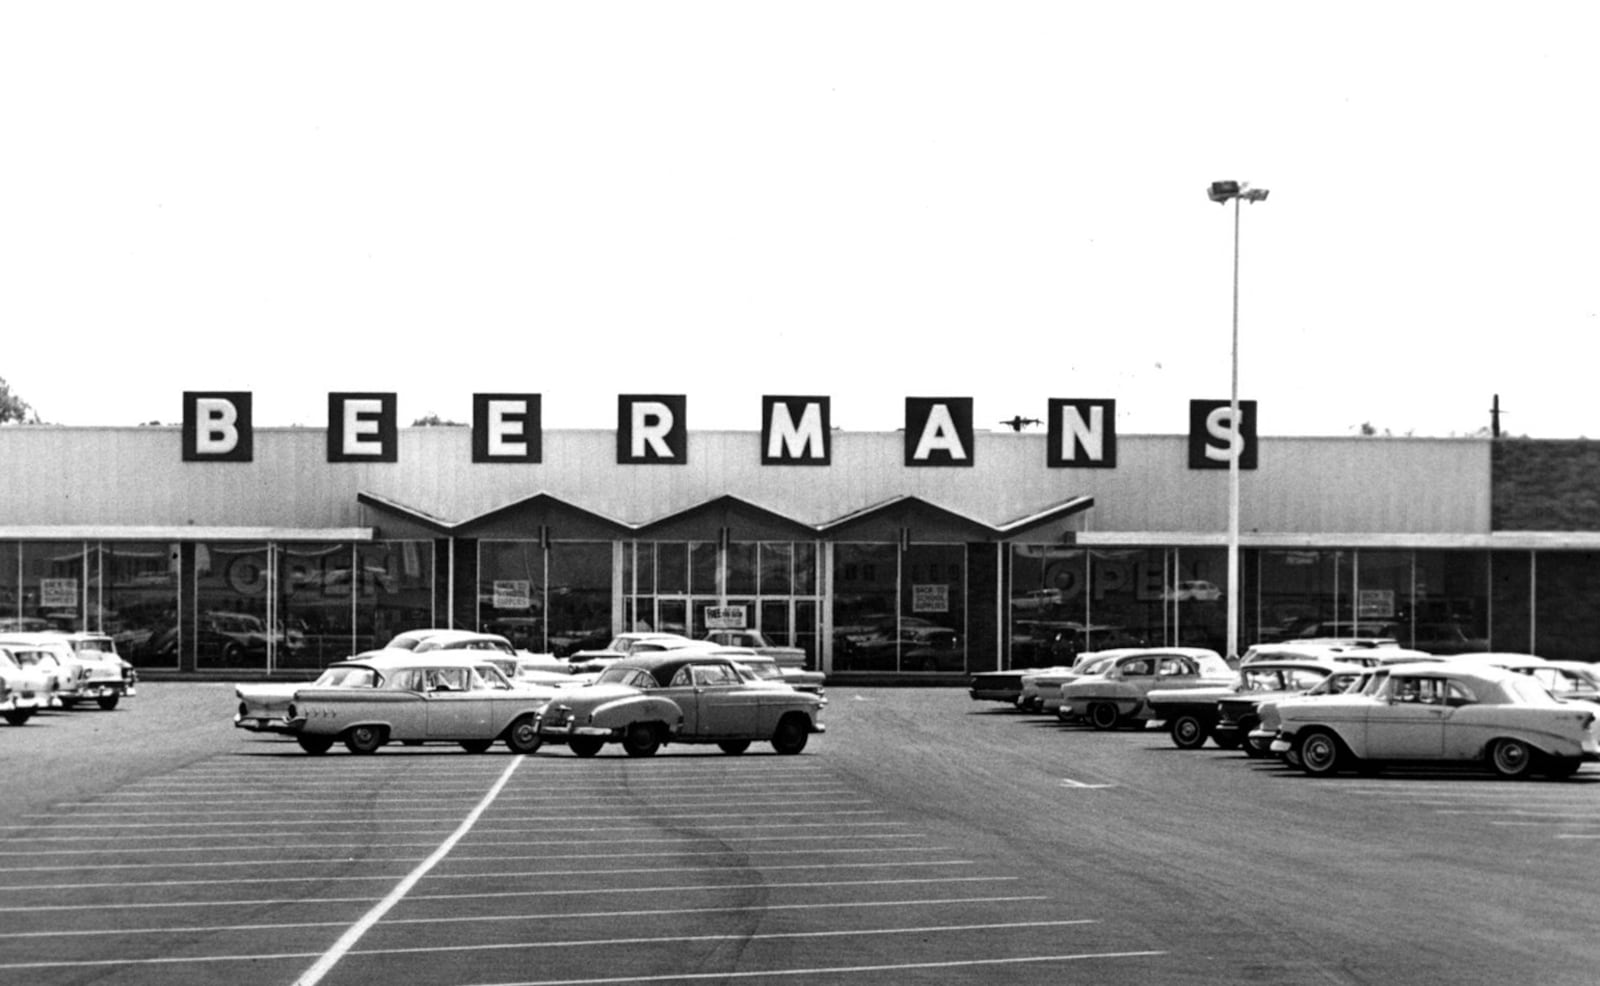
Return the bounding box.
[0,0,1600,437]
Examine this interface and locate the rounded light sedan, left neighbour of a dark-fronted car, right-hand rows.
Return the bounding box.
[1056,647,1234,730]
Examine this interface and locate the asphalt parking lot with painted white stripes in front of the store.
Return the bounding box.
[0,683,1600,984]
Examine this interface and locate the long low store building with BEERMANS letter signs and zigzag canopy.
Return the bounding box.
[0,392,1600,680]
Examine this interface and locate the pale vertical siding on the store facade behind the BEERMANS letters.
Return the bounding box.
[0,427,1491,533]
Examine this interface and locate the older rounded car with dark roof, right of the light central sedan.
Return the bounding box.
[538,648,827,757]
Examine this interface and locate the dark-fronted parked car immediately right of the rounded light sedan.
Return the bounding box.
[1146,655,1358,749]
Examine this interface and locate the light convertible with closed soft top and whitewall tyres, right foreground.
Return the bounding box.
[1272,661,1600,778]
